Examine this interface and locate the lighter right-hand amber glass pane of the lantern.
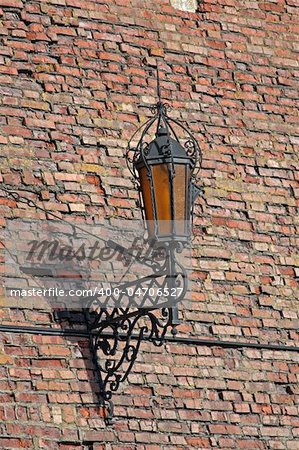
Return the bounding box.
[173,164,187,235]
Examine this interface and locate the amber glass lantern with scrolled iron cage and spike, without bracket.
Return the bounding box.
[127,74,201,242]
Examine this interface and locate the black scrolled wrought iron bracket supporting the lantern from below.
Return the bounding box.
[86,243,187,424]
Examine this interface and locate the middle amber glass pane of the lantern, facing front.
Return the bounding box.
[152,164,172,235]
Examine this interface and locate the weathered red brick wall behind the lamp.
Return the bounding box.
[0,0,299,450]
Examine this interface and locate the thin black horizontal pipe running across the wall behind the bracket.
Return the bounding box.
[0,325,299,352]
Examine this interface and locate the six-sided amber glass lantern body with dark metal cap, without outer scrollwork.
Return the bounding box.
[136,127,197,241]
